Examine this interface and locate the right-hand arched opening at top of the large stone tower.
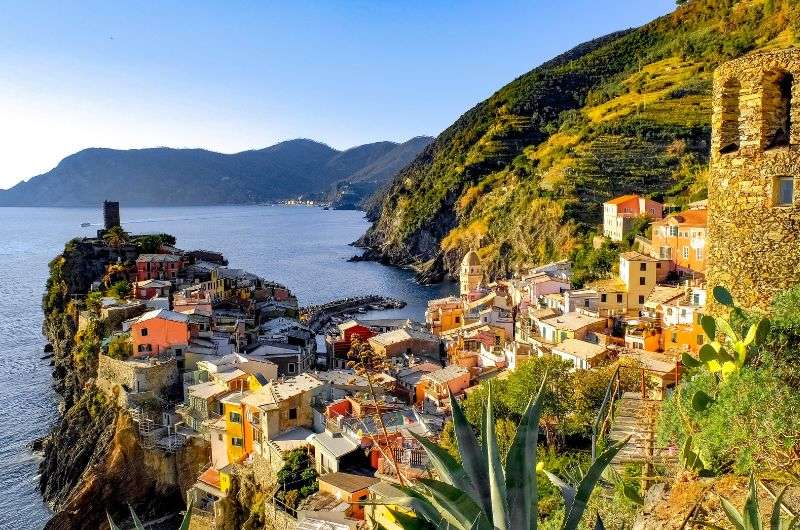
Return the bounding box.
[761,70,794,149]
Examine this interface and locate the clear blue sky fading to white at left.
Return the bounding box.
[0,0,674,188]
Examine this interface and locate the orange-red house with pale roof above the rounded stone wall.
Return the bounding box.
[131,309,189,356]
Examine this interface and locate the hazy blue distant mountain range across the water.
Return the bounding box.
[0,137,432,207]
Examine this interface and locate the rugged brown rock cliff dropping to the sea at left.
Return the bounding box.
[40,240,208,530]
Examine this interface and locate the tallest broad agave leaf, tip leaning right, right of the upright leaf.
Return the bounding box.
[506,373,547,530]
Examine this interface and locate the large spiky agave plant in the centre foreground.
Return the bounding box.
[378,377,627,530]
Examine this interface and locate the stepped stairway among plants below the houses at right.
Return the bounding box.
[608,392,677,467]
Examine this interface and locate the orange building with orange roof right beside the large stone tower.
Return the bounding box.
[652,206,708,272]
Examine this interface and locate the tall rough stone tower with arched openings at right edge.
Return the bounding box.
[707,48,800,310]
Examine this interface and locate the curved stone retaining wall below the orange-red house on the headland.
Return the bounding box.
[96,354,178,407]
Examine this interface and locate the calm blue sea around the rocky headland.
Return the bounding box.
[0,205,455,530]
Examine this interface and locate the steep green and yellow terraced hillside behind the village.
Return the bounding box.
[361,0,800,280]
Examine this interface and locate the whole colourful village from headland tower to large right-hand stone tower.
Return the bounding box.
[48,47,800,529]
